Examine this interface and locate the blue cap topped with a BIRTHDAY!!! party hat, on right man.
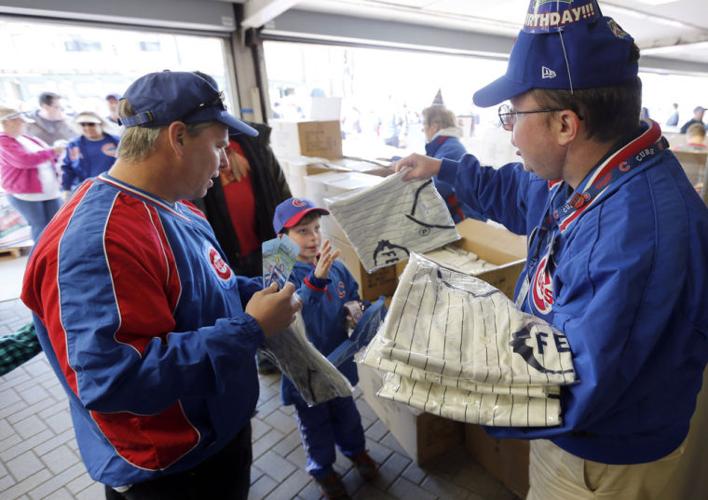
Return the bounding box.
[473,0,639,108]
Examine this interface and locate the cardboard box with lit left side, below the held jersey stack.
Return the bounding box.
[357,365,464,465]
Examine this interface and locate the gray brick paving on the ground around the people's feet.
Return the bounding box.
[0,300,516,500]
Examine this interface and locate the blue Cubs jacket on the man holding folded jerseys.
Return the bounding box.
[439,123,708,464]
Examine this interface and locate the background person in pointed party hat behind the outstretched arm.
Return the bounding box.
[423,90,486,223]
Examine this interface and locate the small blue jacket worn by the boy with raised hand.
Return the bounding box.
[280,260,359,405]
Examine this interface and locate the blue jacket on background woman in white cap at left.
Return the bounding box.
[61,132,120,191]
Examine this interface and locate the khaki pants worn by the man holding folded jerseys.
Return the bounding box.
[526,439,684,500]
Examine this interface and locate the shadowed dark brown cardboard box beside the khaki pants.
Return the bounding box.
[465,424,529,498]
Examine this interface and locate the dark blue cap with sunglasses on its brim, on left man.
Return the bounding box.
[120,71,258,137]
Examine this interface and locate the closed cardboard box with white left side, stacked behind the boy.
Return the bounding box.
[269,120,342,159]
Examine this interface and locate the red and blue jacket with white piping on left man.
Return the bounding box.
[22,174,263,486]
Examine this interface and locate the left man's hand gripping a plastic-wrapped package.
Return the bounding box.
[246,283,302,336]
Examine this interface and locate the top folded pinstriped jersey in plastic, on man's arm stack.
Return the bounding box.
[377,254,575,386]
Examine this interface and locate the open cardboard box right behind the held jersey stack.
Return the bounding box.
[396,219,526,298]
